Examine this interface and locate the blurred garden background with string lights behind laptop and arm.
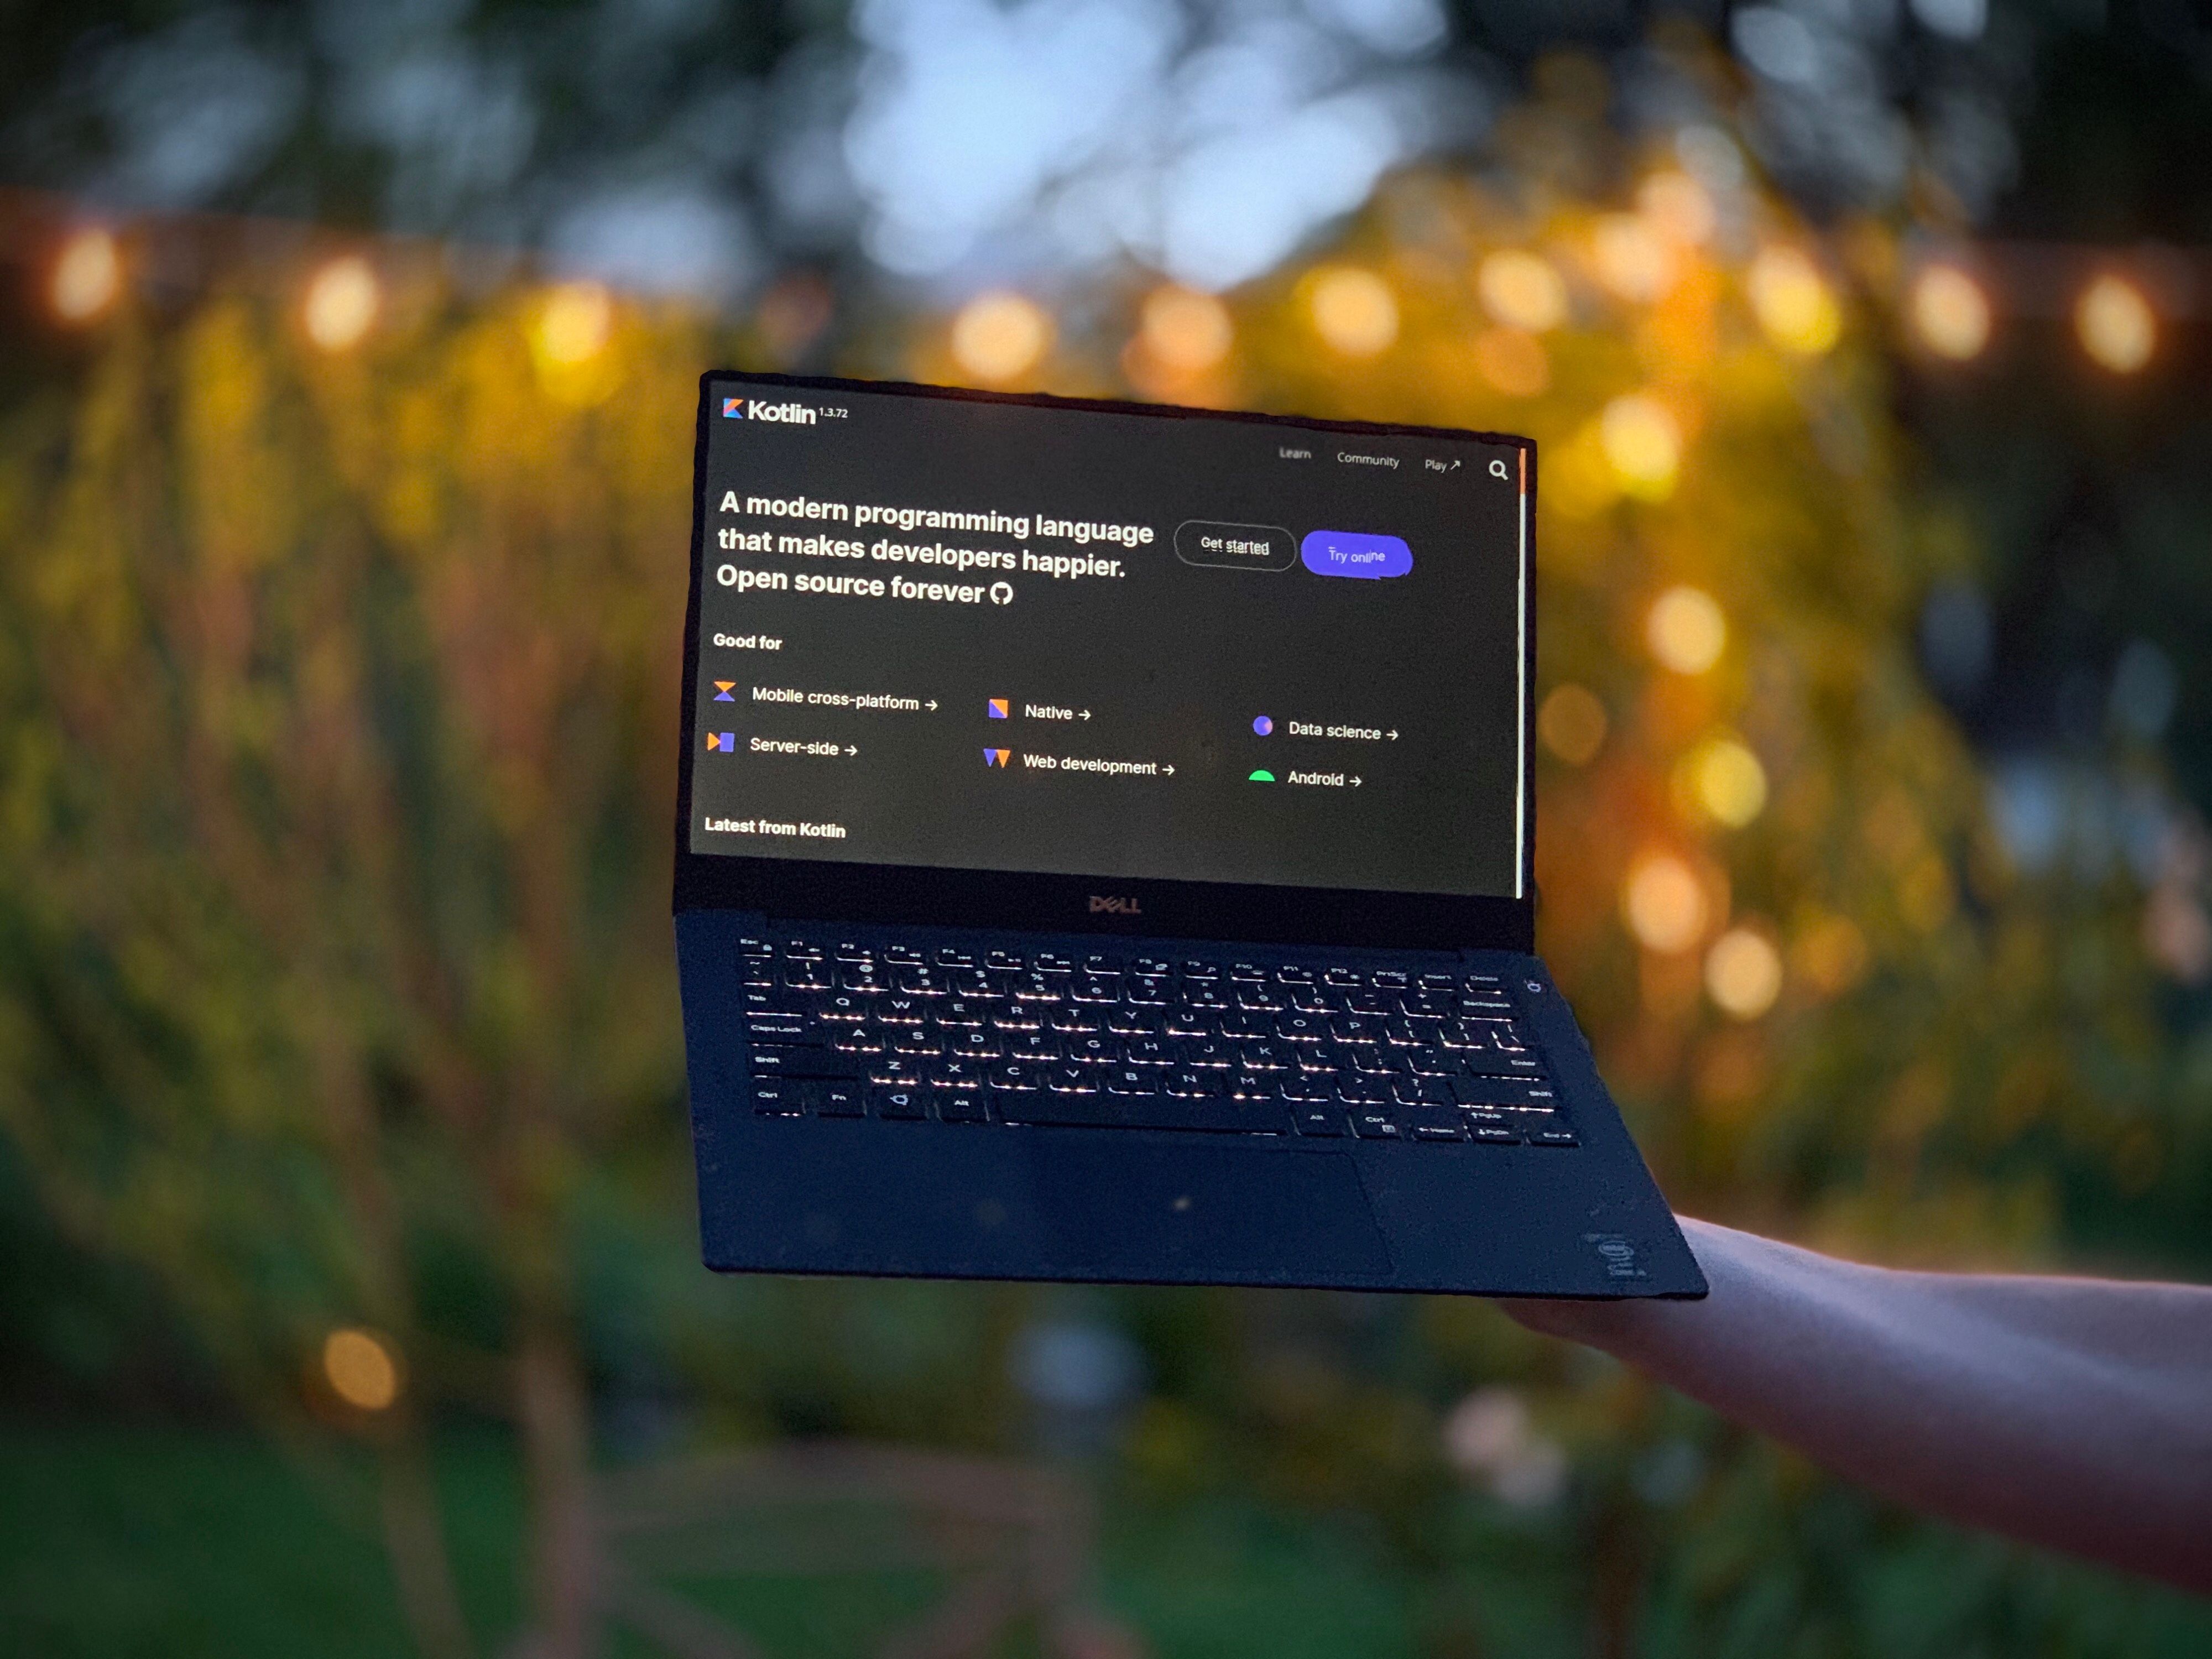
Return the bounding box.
[0,0,2212,1659]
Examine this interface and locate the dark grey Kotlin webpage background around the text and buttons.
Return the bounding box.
[690,380,1522,896]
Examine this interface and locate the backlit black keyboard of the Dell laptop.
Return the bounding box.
[739,938,1575,1146]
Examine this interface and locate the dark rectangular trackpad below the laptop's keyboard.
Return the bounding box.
[1031,1130,1391,1283]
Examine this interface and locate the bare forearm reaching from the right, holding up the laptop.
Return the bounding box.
[1520,1223,2212,1590]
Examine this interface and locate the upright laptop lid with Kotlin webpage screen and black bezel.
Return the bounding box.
[675,372,1535,951]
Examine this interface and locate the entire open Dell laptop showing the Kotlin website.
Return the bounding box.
[675,372,1705,1296]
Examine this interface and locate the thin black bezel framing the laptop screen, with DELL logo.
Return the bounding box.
[675,369,1535,951]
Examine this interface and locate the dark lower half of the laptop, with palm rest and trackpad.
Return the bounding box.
[677,909,1705,1298]
